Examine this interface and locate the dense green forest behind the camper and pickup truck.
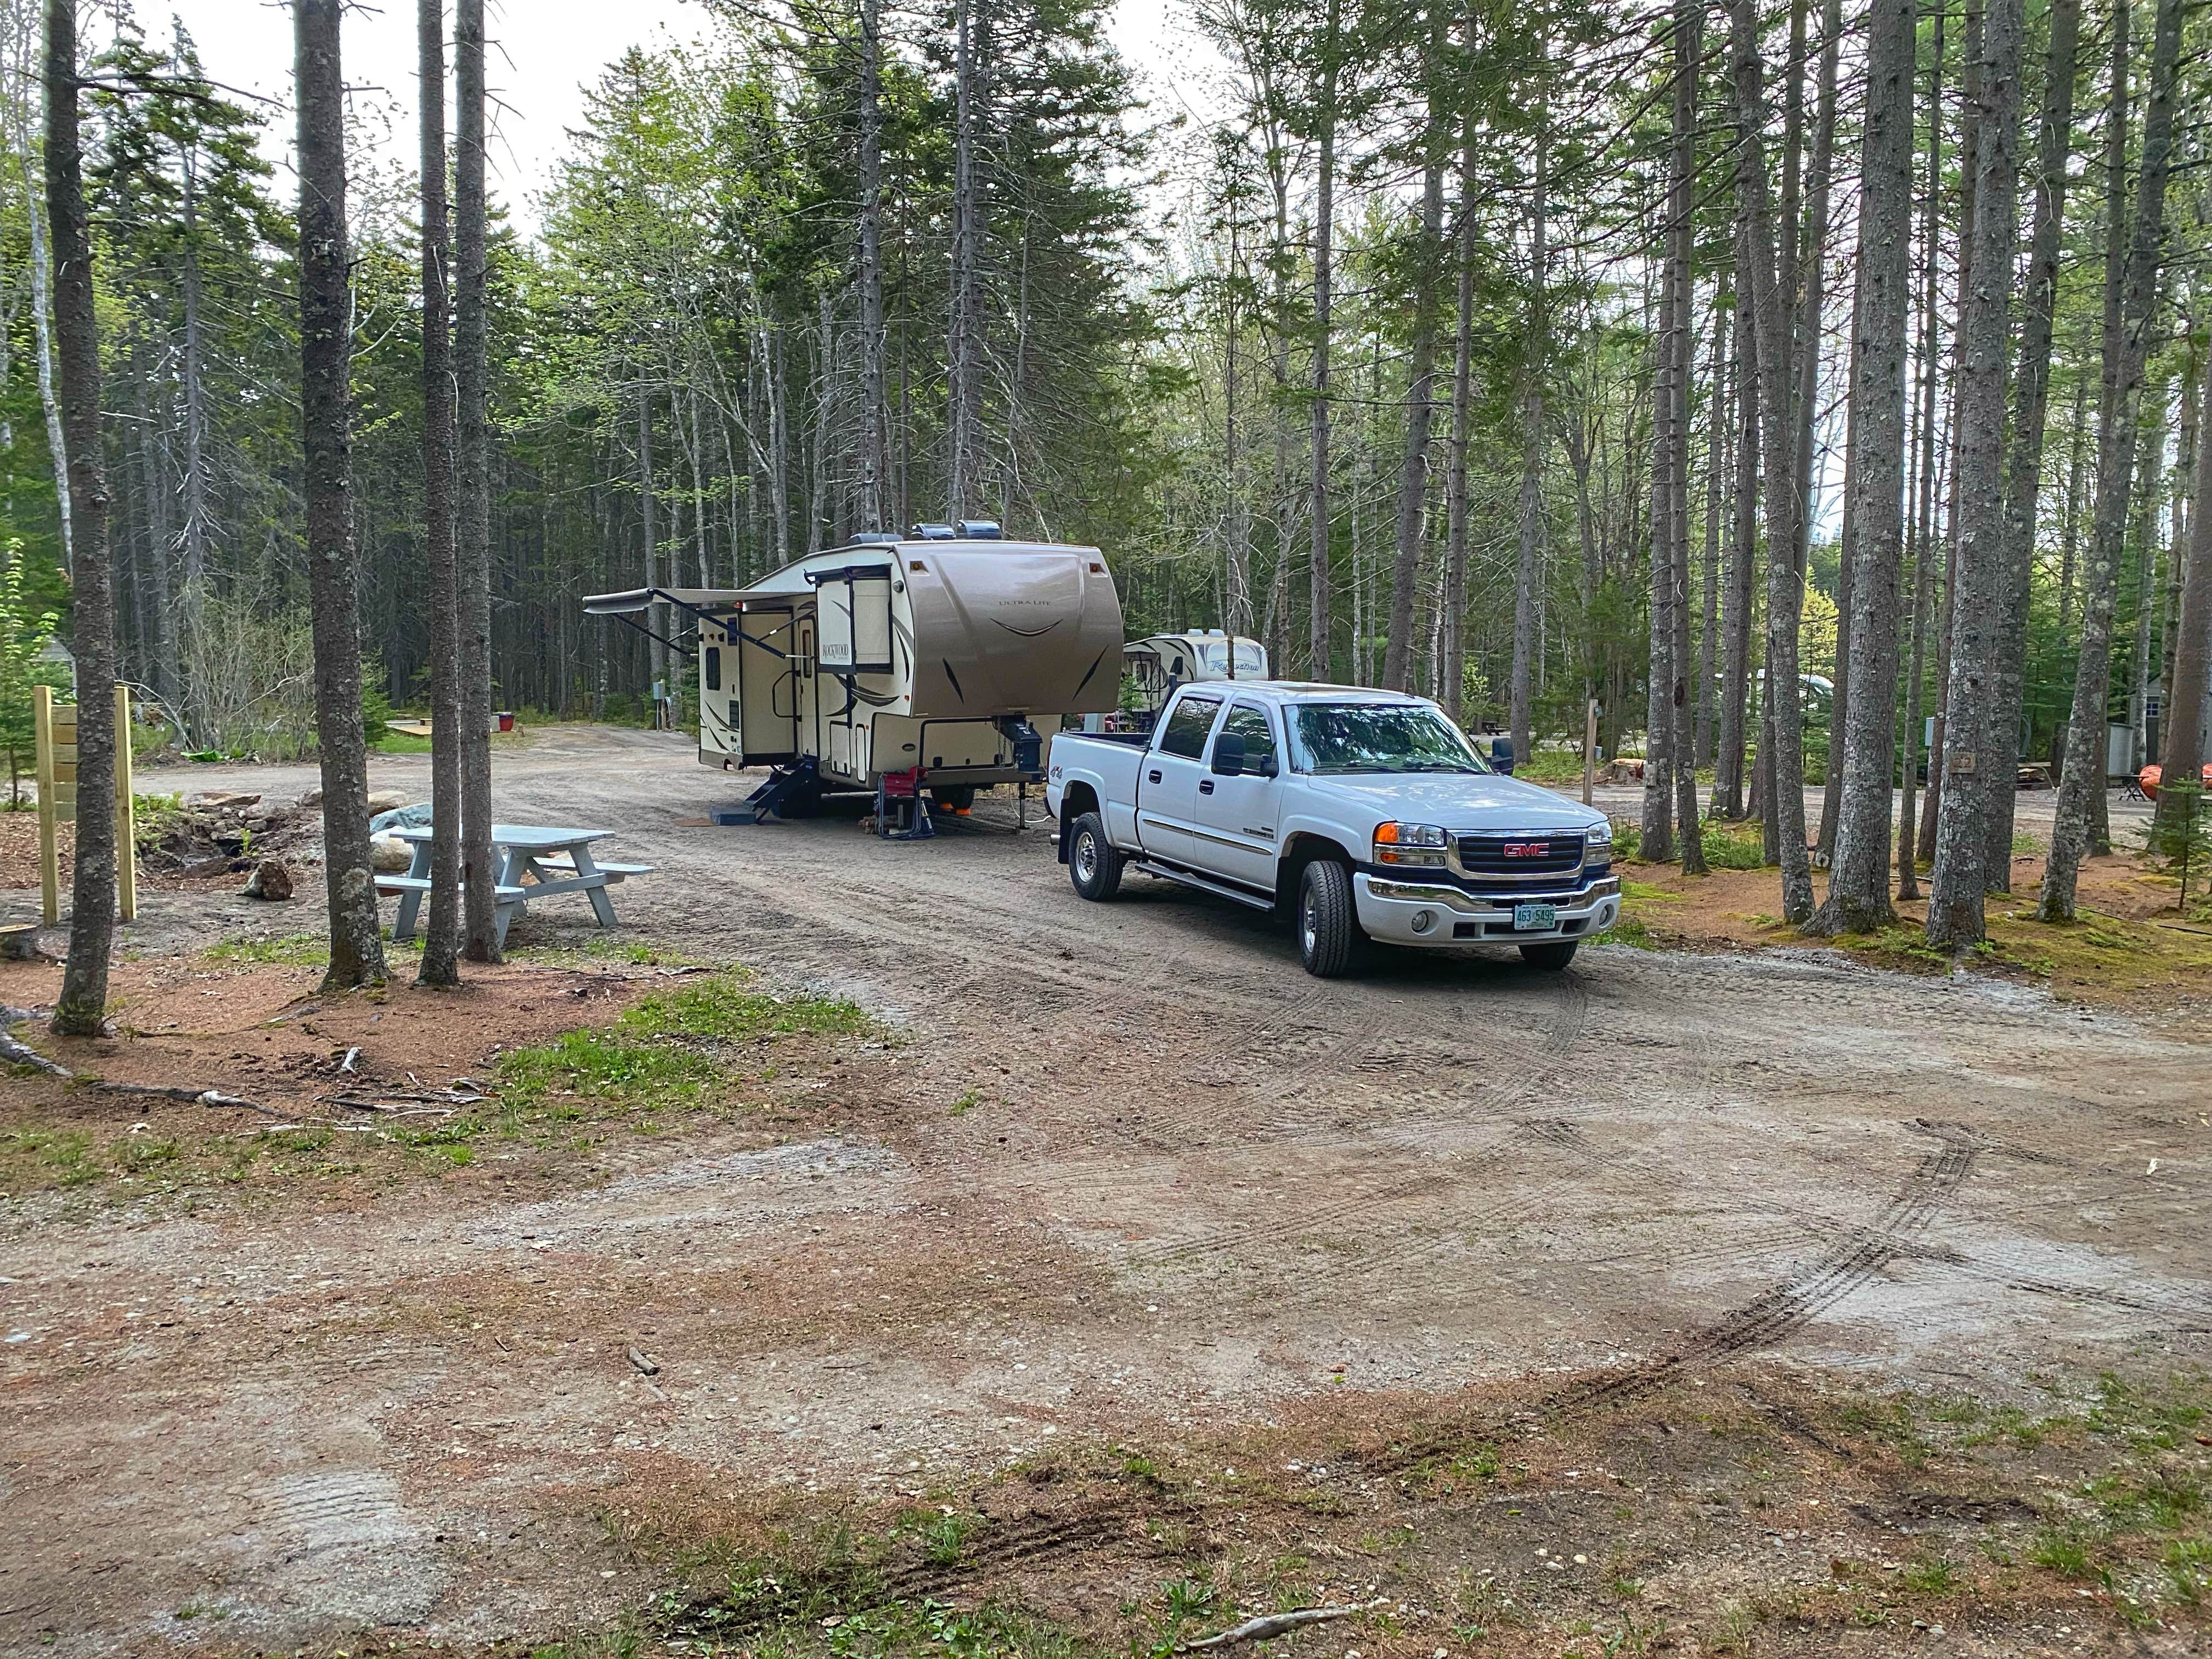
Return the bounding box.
[0,0,2212,946]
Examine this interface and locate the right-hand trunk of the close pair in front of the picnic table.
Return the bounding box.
[454,0,500,962]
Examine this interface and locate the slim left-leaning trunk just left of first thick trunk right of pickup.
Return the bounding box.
[1730,0,1812,924]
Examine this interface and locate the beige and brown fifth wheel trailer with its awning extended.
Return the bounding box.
[584,524,1121,814]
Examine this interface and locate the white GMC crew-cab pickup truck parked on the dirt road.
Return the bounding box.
[1046,681,1621,978]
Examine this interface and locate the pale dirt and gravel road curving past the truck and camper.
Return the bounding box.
[0,730,2212,1655]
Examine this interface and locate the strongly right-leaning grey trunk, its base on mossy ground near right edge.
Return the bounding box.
[2037,0,2181,922]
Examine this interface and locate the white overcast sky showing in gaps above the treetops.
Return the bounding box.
[156,0,1217,230]
